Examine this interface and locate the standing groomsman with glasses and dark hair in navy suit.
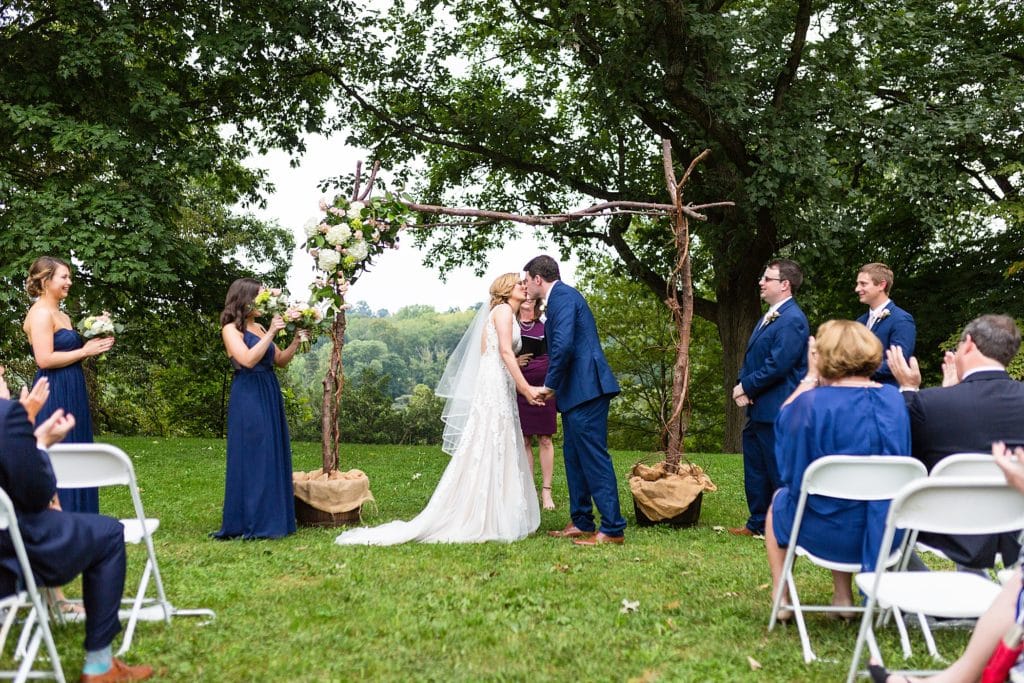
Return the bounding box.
[729,259,810,536]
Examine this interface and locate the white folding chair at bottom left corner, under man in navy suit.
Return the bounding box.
[0,488,65,683]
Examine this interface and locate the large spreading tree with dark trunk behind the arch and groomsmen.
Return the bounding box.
[333,0,1024,450]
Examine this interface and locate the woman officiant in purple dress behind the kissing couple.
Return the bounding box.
[516,299,558,510]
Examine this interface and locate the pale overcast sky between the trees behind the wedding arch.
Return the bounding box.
[243,135,574,313]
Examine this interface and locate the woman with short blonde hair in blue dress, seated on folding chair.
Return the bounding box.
[765,321,910,618]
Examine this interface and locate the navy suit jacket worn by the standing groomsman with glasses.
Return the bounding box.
[738,299,811,422]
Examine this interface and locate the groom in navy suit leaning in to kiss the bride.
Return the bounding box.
[524,256,626,546]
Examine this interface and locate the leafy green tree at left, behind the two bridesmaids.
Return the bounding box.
[0,0,350,353]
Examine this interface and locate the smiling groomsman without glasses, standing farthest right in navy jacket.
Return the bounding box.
[854,263,918,386]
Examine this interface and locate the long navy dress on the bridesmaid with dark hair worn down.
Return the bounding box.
[213,331,295,539]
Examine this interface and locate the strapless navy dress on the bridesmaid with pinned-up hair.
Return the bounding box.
[36,329,99,514]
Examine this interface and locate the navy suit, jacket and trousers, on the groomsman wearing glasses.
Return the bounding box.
[738,298,810,533]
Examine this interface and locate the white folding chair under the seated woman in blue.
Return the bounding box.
[768,456,928,663]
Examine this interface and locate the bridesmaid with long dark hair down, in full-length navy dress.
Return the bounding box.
[213,278,300,539]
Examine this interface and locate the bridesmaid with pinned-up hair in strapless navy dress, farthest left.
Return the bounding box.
[23,256,114,514]
